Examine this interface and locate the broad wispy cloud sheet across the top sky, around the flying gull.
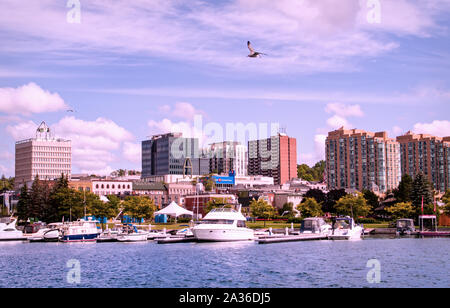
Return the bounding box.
[0,0,448,74]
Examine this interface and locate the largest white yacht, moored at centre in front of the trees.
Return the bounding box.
[192,207,255,242]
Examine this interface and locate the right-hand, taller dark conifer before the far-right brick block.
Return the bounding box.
[411,172,434,216]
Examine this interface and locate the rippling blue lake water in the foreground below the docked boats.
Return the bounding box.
[0,238,450,288]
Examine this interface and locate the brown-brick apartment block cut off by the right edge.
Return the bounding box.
[397,131,450,192]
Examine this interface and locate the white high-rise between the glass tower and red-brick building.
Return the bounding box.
[206,141,247,176]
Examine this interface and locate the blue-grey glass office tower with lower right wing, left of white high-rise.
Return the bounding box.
[142,133,209,179]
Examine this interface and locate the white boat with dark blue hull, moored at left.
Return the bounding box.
[61,219,101,243]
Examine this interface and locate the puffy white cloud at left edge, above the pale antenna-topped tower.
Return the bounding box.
[0,82,67,115]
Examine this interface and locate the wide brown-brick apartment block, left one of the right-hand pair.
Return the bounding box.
[326,128,401,192]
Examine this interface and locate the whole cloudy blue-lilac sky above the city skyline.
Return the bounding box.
[0,0,450,175]
